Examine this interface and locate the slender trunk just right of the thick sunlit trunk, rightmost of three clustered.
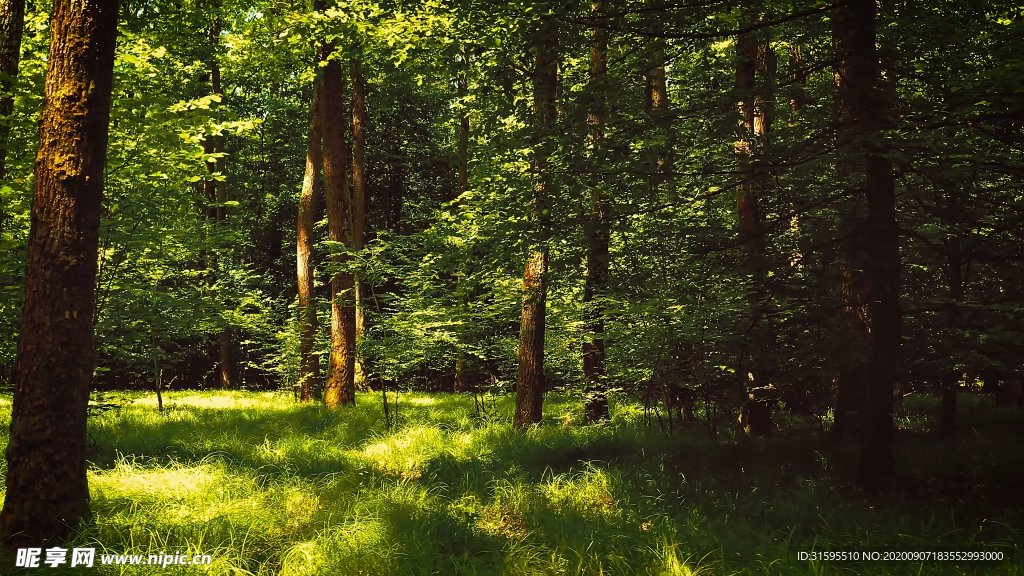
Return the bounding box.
[349,58,367,388]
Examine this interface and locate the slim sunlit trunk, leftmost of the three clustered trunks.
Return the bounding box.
[296,82,324,402]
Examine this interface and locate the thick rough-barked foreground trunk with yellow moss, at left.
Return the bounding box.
[0,0,118,546]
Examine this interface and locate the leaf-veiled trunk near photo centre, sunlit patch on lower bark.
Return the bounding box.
[512,16,558,427]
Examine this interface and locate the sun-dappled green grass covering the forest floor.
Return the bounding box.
[0,392,1024,576]
